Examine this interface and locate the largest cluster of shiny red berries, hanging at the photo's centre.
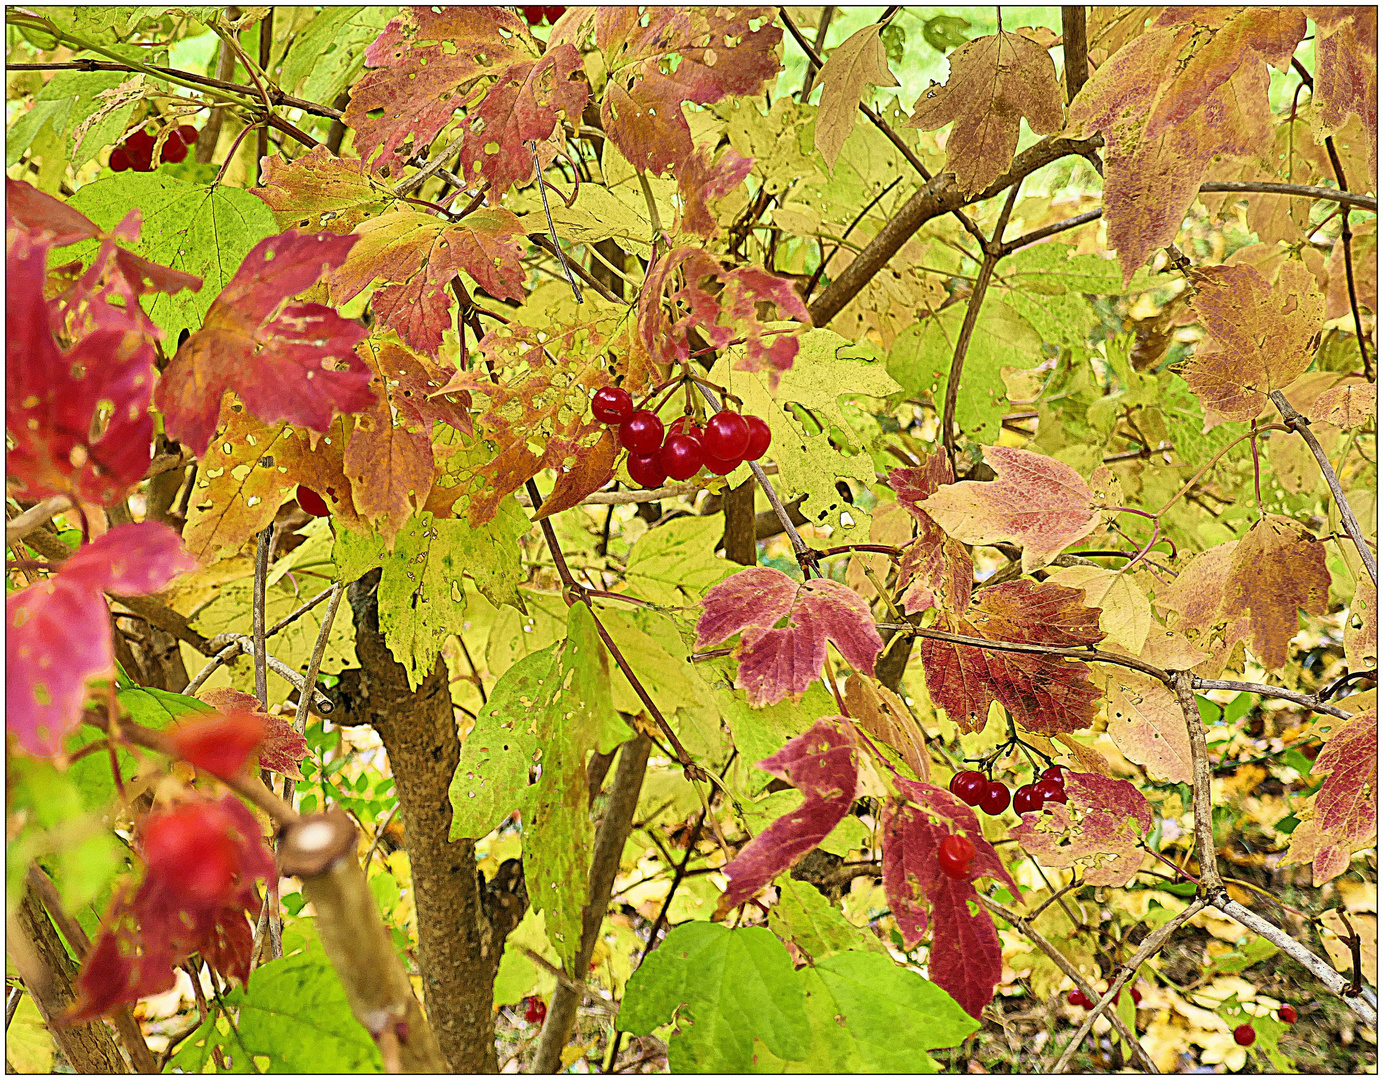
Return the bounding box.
[591,386,773,488]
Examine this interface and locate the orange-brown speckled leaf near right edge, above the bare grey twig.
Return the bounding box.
[1181,261,1325,420]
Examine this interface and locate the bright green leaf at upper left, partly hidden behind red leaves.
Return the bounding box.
[68,170,278,342]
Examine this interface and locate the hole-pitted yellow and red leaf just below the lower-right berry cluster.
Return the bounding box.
[1010,773,1152,888]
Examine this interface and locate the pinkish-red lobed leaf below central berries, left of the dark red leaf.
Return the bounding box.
[696,567,884,708]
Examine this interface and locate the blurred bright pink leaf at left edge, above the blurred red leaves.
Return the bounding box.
[6,521,196,756]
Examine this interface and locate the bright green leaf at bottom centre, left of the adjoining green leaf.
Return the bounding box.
[615,922,810,1073]
